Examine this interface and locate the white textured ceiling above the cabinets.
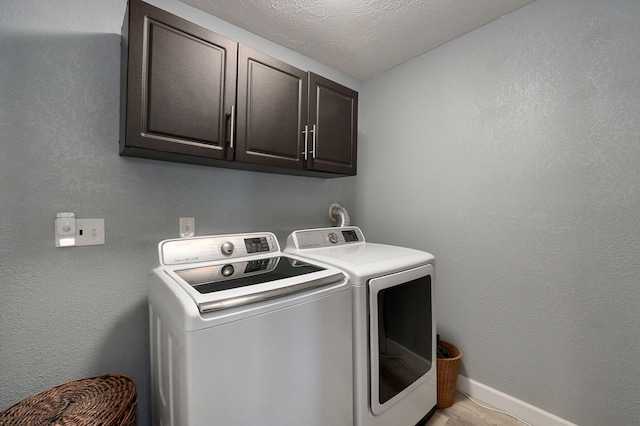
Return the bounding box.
[182,0,534,80]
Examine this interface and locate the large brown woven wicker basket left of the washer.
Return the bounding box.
[0,374,138,426]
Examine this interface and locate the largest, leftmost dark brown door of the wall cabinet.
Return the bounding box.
[120,0,237,160]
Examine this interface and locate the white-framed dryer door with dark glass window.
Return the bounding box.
[370,264,433,414]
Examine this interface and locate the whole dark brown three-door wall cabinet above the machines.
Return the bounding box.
[120,0,358,177]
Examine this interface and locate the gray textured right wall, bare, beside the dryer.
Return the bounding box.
[357,0,640,426]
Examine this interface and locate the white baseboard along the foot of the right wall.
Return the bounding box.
[456,375,577,426]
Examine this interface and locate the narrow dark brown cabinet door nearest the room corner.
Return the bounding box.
[307,72,358,175]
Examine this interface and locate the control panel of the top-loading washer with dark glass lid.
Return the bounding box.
[158,232,280,265]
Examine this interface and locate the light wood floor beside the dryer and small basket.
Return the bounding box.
[426,392,526,426]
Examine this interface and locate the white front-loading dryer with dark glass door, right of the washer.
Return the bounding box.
[285,226,437,426]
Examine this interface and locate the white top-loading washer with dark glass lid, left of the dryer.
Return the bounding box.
[149,233,353,426]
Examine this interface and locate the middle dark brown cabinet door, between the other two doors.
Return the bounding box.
[236,45,308,170]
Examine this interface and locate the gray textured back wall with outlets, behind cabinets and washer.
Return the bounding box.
[0,0,361,425]
